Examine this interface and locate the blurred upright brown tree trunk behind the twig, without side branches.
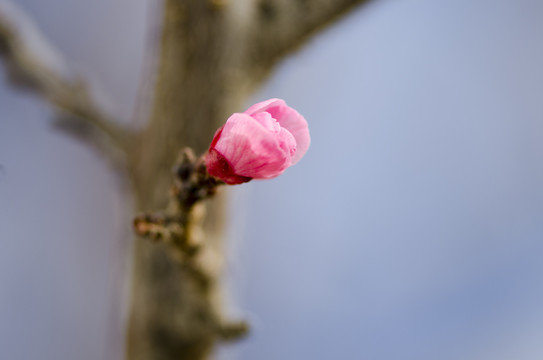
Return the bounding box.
[127,0,248,360]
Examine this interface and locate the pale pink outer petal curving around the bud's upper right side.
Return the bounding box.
[244,99,311,165]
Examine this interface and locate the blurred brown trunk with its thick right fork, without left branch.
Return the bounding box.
[127,0,374,360]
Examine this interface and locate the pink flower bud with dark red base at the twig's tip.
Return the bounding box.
[206,99,310,185]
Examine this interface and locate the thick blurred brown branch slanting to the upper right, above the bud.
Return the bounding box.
[249,0,368,71]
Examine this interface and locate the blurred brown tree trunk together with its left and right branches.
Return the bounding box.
[0,0,372,360]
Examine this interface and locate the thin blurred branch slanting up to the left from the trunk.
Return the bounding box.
[0,0,132,158]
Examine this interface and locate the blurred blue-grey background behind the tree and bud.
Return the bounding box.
[0,0,543,360]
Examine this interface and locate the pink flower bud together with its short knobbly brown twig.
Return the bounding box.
[134,99,311,256]
